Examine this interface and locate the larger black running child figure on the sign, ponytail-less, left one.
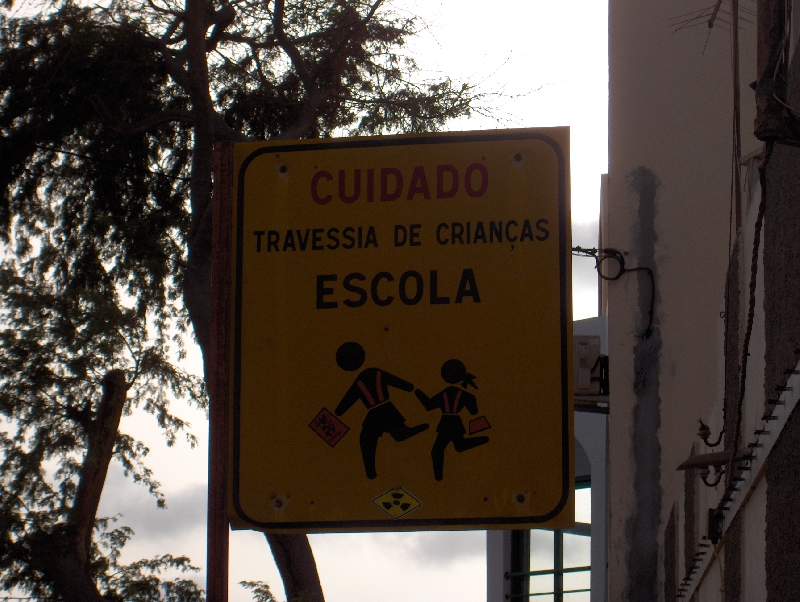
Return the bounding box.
[335,342,429,479]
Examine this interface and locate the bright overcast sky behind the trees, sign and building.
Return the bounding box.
[95,0,608,602]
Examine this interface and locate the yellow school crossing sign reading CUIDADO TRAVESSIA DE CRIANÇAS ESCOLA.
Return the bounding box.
[229,128,573,531]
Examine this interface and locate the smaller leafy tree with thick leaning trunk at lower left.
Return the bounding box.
[0,234,209,602]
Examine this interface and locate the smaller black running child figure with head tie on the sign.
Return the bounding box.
[414,359,489,481]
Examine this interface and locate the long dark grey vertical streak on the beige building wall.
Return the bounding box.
[626,167,662,602]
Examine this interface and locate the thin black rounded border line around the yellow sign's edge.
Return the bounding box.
[232,130,574,533]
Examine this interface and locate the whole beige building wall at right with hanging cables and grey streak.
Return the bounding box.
[604,0,800,602]
